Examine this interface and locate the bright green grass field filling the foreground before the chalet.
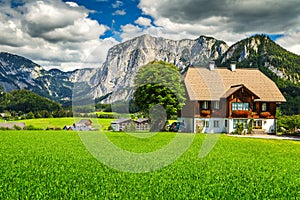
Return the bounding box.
[0,131,300,199]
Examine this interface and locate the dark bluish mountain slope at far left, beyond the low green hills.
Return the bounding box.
[0,52,92,102]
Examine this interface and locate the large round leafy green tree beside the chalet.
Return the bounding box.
[134,61,185,130]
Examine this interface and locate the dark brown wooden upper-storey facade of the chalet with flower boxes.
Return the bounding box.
[179,87,276,119]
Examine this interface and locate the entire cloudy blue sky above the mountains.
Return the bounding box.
[0,0,300,71]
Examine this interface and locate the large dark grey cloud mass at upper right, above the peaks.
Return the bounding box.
[139,0,300,54]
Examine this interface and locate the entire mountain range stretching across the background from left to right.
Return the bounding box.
[0,35,300,114]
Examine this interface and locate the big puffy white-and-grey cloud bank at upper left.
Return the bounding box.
[0,0,118,70]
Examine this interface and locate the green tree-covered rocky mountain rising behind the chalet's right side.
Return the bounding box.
[216,35,300,114]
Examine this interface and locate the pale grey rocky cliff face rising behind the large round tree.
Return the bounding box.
[85,35,228,103]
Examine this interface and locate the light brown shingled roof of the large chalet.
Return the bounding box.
[184,67,286,102]
